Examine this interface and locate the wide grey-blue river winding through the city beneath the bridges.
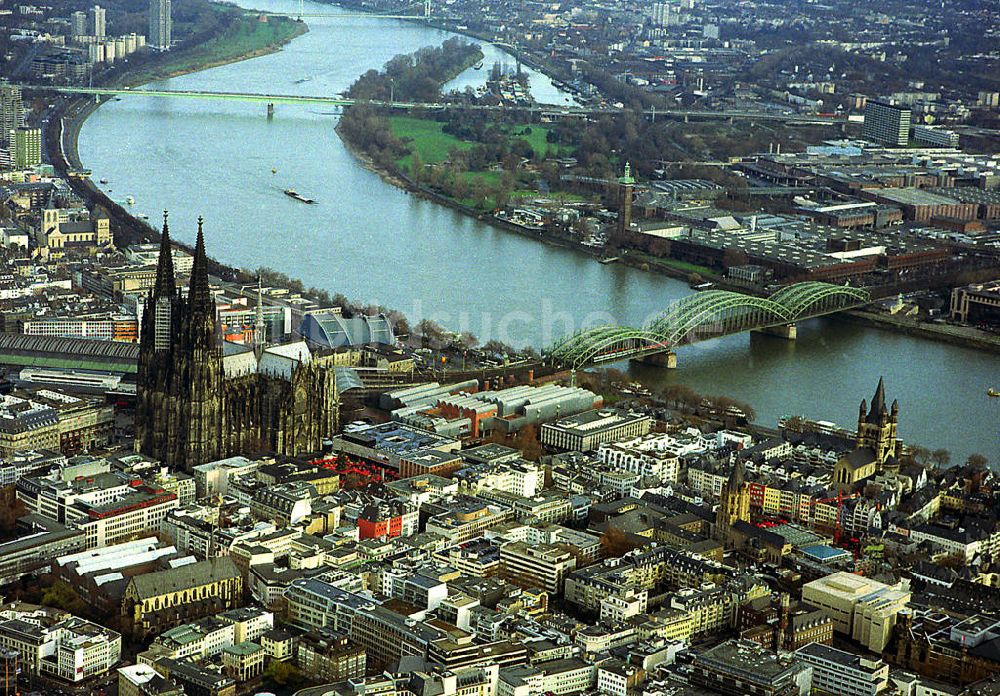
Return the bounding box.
[79,0,1000,463]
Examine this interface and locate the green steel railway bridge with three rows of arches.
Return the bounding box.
[543,281,872,370]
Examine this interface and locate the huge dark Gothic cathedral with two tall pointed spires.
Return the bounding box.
[136,215,338,471]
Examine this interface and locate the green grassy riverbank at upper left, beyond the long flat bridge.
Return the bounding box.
[115,10,309,85]
